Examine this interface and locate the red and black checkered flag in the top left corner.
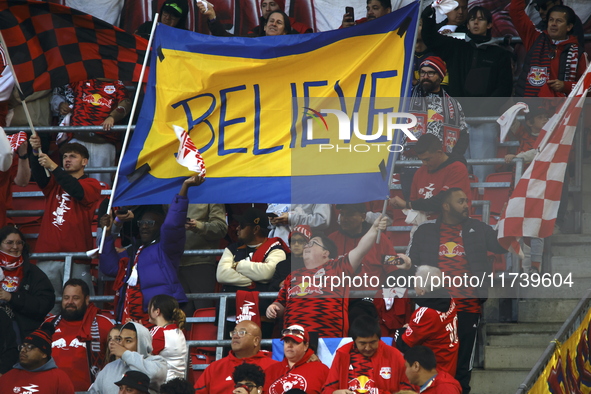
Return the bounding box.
[0,0,148,97]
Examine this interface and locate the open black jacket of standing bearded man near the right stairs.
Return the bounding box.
[408,216,507,298]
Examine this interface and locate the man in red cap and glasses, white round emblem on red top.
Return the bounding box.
[265,325,328,394]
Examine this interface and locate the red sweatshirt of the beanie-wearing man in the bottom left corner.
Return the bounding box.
[0,358,75,394]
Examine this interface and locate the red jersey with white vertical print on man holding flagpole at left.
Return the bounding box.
[35,176,101,253]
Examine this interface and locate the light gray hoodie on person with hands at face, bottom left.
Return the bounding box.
[88,323,167,394]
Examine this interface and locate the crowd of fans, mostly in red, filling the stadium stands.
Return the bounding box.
[0,0,585,394]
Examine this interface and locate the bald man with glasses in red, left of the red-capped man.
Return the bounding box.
[195,320,279,394]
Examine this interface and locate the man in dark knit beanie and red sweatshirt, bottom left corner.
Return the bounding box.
[0,323,74,394]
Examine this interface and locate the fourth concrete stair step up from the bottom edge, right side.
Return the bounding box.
[517,298,579,323]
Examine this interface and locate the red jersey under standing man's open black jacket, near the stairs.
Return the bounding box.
[439,223,480,313]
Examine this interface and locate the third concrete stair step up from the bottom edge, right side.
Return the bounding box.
[485,323,561,347]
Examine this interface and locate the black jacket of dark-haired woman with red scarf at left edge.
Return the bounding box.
[8,257,55,343]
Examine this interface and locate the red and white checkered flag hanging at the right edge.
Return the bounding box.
[498,66,591,254]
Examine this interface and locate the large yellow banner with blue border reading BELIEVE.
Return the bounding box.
[115,2,419,205]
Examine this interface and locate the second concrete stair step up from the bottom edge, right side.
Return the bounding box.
[484,346,546,374]
